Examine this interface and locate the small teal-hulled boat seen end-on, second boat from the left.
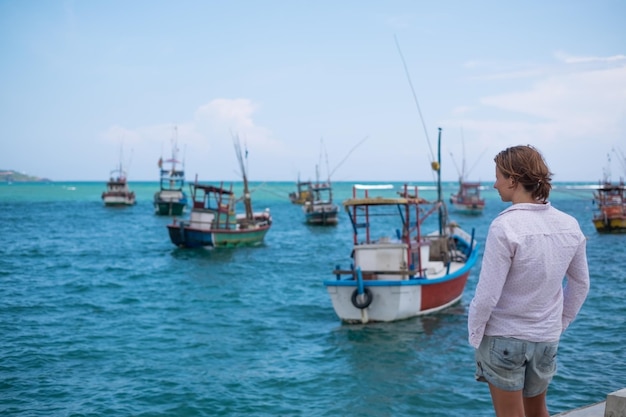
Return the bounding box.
[154,128,187,216]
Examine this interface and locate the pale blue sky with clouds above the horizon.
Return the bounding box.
[0,0,626,182]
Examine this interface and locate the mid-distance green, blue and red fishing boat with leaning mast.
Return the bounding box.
[167,136,272,248]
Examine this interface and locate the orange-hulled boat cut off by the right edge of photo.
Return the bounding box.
[593,180,626,233]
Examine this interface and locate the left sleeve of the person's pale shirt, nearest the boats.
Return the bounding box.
[467,223,514,348]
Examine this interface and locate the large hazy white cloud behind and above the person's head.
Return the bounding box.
[454,58,626,180]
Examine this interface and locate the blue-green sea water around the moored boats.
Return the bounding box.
[0,182,626,417]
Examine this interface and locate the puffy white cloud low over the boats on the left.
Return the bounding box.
[101,98,296,180]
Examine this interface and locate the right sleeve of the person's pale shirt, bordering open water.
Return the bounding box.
[562,237,590,331]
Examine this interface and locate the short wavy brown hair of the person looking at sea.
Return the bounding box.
[494,145,553,203]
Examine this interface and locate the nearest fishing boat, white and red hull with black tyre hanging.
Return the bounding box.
[324,130,478,323]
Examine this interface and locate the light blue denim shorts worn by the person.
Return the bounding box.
[476,336,559,397]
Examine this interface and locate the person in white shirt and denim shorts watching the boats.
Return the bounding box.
[468,145,589,417]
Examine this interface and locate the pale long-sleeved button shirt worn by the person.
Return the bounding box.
[468,203,589,348]
